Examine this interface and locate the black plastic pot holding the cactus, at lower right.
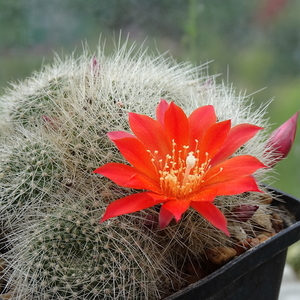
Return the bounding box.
[165,188,300,300]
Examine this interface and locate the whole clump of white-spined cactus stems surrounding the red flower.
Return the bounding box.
[0,44,278,300]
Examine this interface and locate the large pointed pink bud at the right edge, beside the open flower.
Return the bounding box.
[266,111,300,167]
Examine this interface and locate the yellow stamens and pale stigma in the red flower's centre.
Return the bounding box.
[152,141,211,199]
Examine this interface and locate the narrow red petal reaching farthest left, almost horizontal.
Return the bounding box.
[93,163,161,193]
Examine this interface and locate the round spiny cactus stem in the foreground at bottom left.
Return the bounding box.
[6,199,175,300]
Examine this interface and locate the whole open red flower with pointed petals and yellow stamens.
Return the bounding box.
[94,100,265,235]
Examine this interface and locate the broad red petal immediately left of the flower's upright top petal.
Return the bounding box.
[129,113,172,159]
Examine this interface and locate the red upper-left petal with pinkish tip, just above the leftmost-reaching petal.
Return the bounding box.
[110,134,157,179]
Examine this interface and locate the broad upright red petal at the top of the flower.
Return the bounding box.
[164,102,189,148]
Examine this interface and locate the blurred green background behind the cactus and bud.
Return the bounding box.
[0,0,300,198]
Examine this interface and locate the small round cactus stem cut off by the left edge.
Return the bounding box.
[1,129,63,221]
